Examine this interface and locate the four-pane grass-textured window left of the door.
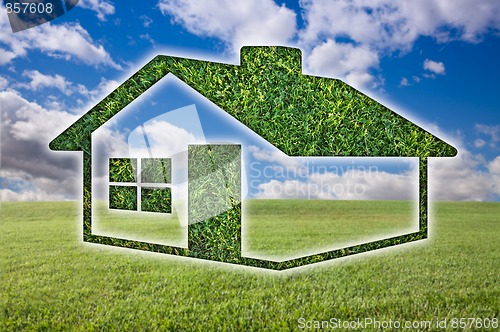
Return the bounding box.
[109,158,172,213]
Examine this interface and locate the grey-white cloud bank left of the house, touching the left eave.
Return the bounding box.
[0,90,81,200]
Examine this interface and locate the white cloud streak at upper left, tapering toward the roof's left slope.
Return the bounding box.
[0,15,121,69]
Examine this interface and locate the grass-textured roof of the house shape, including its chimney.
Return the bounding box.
[50,46,457,157]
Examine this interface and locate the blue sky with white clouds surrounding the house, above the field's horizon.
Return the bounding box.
[0,0,500,201]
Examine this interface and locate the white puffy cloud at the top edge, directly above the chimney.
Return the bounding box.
[158,0,297,51]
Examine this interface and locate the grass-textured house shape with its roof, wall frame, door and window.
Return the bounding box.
[50,47,457,270]
